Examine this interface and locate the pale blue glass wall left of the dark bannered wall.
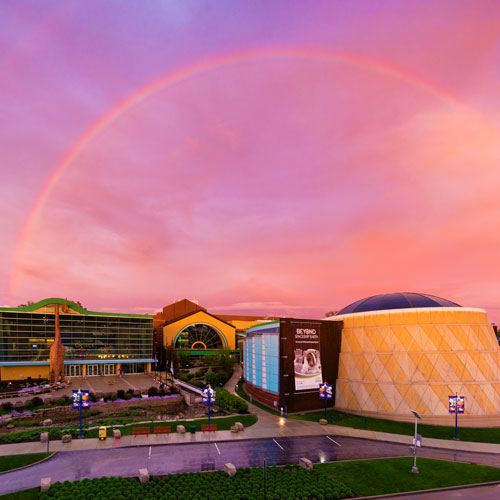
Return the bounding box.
[243,323,280,394]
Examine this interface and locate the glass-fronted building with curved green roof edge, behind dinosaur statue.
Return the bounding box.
[0,298,153,380]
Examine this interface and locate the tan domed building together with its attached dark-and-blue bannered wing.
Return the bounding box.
[244,293,500,426]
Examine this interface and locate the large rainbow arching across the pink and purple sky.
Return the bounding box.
[9,48,484,296]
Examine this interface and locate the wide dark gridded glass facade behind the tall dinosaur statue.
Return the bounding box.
[0,310,153,363]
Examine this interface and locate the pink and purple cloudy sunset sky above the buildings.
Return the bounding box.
[0,0,500,321]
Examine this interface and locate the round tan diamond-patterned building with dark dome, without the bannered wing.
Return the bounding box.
[326,293,500,426]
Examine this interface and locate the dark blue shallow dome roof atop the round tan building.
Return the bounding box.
[337,292,462,316]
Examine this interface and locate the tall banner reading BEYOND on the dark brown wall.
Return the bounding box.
[291,323,323,391]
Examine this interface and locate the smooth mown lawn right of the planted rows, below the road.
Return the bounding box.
[314,457,500,496]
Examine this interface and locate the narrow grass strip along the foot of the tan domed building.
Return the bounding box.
[290,410,500,444]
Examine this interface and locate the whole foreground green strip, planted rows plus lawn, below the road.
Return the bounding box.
[0,457,500,500]
